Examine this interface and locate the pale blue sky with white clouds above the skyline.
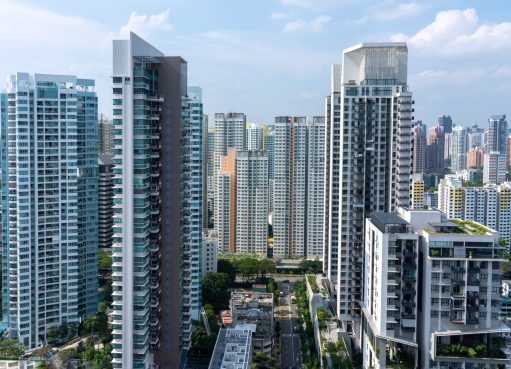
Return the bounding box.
[0,0,511,126]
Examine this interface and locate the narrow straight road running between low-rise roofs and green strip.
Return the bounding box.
[277,278,302,369]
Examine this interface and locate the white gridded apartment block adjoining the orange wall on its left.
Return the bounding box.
[235,150,268,257]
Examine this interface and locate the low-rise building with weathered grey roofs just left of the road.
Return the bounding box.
[230,291,275,355]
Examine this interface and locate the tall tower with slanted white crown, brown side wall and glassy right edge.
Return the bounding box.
[112,33,203,369]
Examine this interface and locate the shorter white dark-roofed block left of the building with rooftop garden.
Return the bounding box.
[362,212,420,369]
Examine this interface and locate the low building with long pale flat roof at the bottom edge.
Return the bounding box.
[208,328,252,369]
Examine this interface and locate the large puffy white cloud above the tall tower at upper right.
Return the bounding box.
[391,8,511,56]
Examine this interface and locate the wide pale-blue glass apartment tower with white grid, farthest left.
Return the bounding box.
[0,73,98,348]
